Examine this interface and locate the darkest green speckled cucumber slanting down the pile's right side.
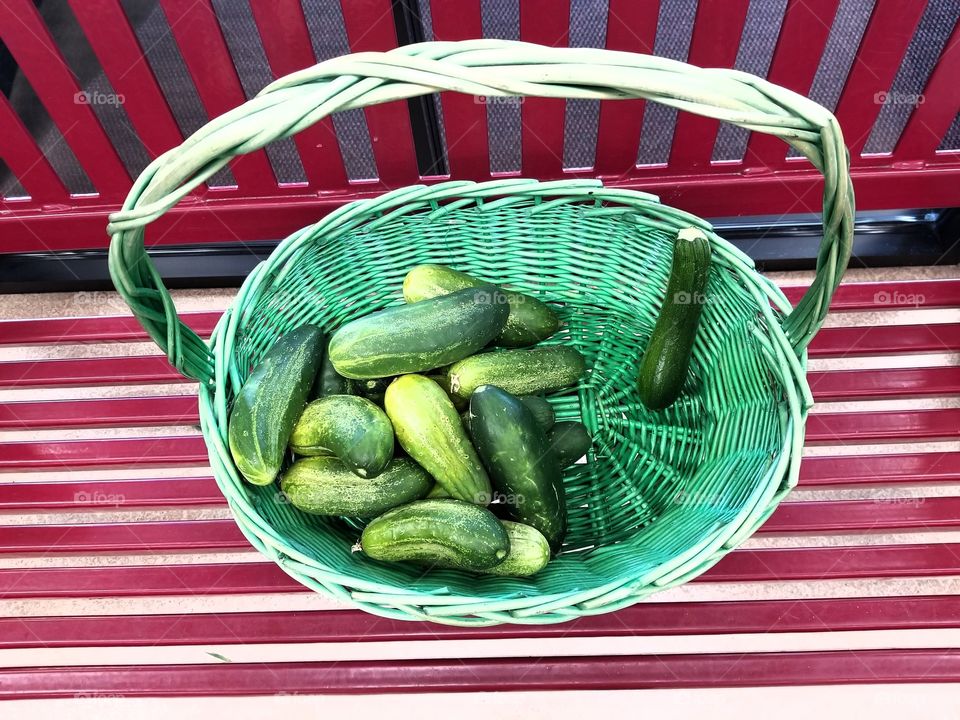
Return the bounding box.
[470,385,567,552]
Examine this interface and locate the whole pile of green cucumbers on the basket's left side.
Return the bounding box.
[228,265,591,576]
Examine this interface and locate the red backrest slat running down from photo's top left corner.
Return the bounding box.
[0,0,131,195]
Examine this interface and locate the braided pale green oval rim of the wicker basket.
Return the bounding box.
[199,180,812,625]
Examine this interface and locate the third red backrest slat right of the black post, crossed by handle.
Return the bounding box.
[593,0,660,176]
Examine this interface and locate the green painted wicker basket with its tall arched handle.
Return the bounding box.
[109,40,853,625]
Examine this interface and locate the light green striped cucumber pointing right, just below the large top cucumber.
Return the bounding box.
[449,345,587,398]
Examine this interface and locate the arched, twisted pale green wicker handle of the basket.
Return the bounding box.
[107,40,854,384]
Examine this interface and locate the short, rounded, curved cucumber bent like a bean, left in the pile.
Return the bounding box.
[290,395,393,477]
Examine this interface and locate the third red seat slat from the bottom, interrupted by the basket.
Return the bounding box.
[0,543,960,599]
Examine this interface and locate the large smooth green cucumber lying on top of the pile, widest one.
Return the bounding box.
[329,285,509,380]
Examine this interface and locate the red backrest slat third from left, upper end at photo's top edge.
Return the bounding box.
[70,0,183,157]
